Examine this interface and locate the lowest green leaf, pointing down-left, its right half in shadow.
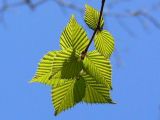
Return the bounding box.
[52,79,85,115]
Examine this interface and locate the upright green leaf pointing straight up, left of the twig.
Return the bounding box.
[60,16,89,52]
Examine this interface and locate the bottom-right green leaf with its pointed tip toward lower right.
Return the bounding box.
[82,73,113,103]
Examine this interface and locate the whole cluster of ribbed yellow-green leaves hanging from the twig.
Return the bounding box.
[31,5,114,115]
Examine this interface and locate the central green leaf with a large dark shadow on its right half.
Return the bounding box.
[52,48,83,79]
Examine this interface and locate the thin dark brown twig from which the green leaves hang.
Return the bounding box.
[81,0,105,60]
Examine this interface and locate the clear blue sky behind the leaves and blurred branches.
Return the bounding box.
[0,0,160,120]
